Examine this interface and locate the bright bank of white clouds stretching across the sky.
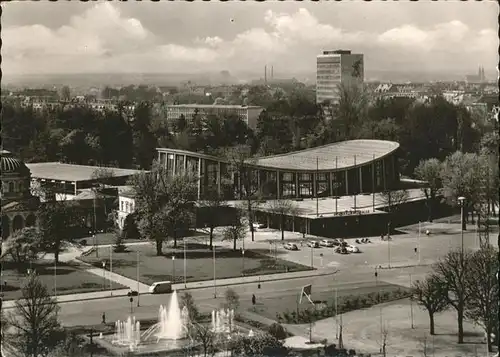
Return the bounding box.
[2,2,498,73]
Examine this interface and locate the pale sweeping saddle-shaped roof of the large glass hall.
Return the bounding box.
[252,140,399,171]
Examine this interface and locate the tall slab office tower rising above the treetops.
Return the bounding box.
[316,50,364,104]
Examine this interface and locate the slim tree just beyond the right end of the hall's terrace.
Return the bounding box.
[415,158,442,222]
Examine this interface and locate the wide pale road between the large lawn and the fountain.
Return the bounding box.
[42,266,429,326]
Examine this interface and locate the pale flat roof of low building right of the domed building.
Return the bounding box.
[26,162,145,182]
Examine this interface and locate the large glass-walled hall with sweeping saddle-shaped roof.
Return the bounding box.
[157,140,399,200]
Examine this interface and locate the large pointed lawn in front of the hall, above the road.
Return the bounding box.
[81,243,310,284]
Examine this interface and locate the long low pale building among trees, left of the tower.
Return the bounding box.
[166,104,264,130]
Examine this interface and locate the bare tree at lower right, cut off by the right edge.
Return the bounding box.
[465,246,499,352]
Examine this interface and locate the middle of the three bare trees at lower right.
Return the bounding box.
[433,250,471,343]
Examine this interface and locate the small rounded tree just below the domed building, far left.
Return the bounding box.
[5,227,40,271]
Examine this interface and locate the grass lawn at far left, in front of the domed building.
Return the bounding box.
[1,261,127,300]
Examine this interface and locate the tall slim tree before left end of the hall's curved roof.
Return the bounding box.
[224,145,260,241]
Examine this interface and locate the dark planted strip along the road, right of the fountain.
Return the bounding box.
[241,283,407,323]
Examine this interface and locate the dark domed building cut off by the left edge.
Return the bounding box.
[0,150,40,238]
